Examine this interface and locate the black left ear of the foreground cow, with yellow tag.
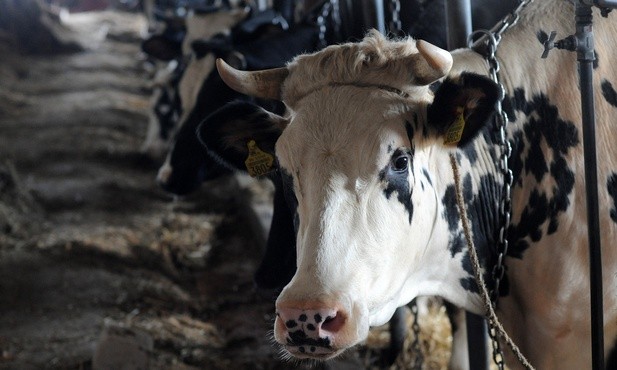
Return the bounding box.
[197,102,287,176]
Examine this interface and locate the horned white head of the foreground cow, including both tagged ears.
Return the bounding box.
[200,32,498,358]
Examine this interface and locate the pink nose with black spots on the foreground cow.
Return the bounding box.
[276,308,347,357]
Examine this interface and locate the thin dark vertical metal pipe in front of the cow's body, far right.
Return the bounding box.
[576,1,604,370]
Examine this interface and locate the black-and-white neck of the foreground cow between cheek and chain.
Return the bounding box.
[431,131,503,312]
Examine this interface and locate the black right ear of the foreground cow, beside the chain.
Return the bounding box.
[427,73,499,146]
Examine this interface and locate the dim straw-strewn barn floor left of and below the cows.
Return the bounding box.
[0,8,450,370]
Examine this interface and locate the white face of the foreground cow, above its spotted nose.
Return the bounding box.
[275,86,438,330]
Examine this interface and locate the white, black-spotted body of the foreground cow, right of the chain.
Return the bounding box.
[453,1,617,369]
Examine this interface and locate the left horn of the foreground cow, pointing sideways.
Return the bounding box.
[216,58,289,100]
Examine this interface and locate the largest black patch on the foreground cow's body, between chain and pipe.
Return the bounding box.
[508,89,580,258]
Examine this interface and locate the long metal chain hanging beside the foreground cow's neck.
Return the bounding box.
[468,0,533,370]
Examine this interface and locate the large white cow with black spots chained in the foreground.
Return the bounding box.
[200,0,617,369]
